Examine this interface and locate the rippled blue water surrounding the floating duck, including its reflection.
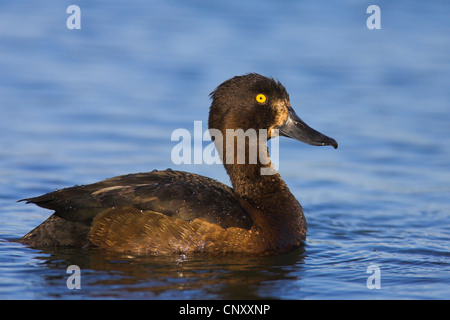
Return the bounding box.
[0,0,450,299]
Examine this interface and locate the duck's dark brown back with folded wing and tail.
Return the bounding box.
[22,169,253,246]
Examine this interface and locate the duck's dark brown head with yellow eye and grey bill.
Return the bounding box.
[209,73,338,148]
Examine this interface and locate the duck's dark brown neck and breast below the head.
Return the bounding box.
[218,139,306,250]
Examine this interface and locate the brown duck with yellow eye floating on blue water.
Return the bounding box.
[19,73,338,256]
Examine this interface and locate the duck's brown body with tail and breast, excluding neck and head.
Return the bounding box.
[22,169,306,254]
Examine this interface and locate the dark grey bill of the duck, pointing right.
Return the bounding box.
[278,108,338,149]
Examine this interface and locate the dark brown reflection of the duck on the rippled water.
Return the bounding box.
[18,248,304,299]
